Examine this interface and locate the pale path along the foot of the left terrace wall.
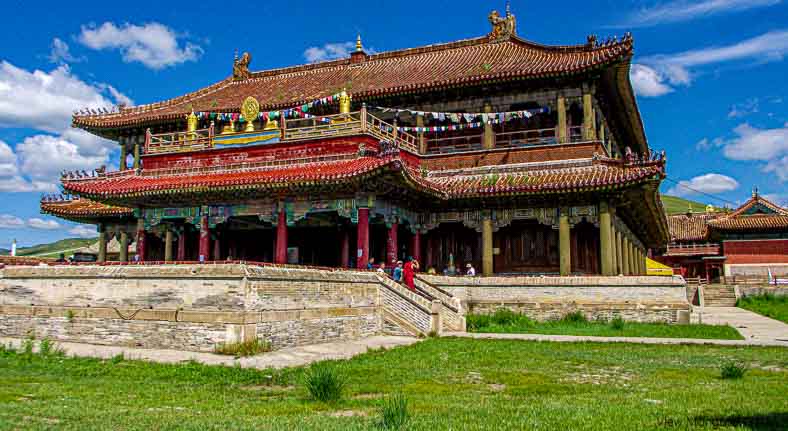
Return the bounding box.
[0,336,419,370]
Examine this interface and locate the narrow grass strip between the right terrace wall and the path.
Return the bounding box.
[466,309,744,340]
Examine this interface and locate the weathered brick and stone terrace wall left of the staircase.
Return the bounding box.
[0,264,382,351]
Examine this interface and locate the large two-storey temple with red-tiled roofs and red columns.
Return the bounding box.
[41,12,669,275]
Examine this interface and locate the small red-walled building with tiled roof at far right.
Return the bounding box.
[654,190,788,281]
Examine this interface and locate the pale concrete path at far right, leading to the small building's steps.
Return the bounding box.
[692,307,788,343]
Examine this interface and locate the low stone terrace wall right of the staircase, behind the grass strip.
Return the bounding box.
[420,275,690,322]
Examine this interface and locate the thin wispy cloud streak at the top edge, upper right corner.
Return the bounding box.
[623,0,781,27]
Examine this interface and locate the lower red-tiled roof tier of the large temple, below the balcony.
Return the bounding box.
[63,155,664,201]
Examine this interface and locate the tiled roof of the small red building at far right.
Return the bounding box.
[668,191,788,242]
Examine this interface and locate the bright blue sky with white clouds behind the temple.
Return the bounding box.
[0,0,788,248]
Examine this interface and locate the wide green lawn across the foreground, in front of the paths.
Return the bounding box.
[0,338,788,431]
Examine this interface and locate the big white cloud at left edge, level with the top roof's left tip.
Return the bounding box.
[0,61,128,133]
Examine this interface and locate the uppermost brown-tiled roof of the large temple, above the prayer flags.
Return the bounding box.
[73,36,633,129]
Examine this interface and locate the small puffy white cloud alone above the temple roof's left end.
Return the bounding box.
[79,22,203,70]
